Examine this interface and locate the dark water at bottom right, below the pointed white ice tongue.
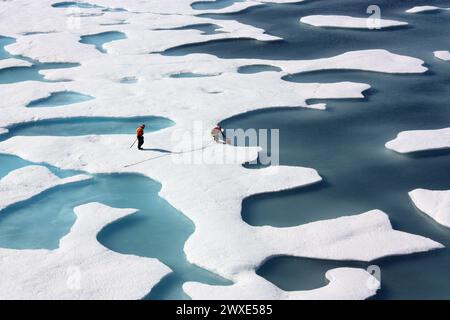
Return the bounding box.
[257,250,450,300]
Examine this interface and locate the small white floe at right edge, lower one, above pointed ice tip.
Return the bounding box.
[408,189,450,228]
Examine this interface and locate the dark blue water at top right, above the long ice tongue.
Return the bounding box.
[165,0,450,60]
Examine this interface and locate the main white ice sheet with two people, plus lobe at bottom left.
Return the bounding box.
[0,0,441,299]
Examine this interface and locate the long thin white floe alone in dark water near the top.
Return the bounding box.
[300,15,408,29]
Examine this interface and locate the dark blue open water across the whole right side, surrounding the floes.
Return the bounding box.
[164,0,450,299]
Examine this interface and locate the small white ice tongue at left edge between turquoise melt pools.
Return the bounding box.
[0,166,90,211]
